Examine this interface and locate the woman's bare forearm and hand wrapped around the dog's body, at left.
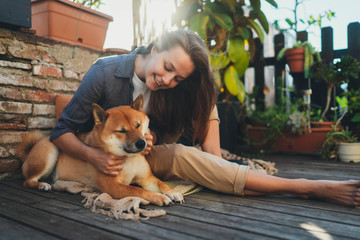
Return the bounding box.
[53,132,126,176]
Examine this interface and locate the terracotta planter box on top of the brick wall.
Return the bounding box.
[31,0,113,51]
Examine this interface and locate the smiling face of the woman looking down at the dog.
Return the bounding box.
[145,46,195,91]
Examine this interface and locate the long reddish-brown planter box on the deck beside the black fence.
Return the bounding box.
[247,126,332,154]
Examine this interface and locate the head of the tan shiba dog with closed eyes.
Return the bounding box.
[93,94,149,156]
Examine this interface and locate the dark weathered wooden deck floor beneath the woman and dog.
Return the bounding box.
[0,155,360,240]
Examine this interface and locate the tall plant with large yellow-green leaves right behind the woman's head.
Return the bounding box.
[176,0,277,102]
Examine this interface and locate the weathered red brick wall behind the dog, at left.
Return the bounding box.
[0,28,129,179]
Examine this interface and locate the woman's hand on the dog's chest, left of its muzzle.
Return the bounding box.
[88,148,127,177]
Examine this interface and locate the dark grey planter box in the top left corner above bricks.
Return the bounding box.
[0,0,31,28]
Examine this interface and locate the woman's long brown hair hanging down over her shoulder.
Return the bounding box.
[140,29,216,143]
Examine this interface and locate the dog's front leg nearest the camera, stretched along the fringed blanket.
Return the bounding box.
[97,176,172,206]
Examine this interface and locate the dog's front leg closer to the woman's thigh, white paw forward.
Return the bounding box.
[138,175,184,203]
